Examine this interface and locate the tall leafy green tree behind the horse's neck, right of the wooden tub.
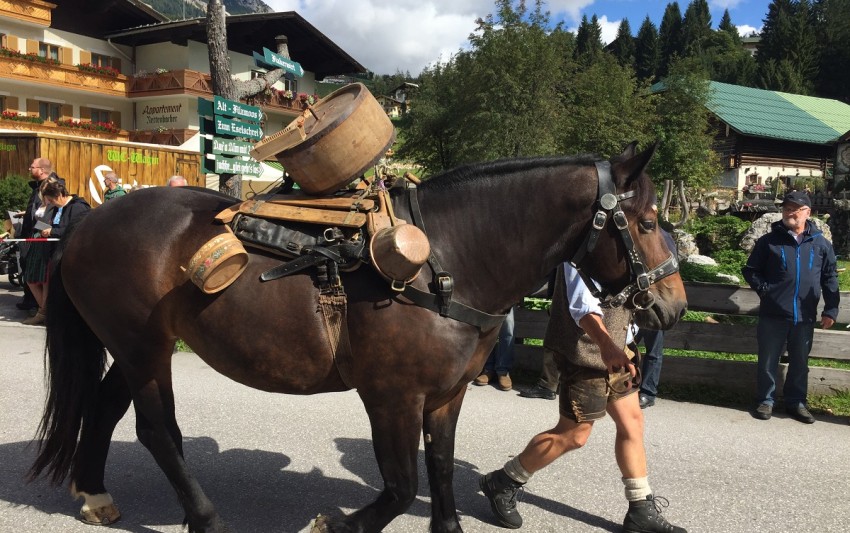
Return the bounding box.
[397,0,573,169]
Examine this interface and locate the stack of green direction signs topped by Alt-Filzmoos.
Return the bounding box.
[198,96,263,176]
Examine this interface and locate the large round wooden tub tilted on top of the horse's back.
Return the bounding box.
[251,83,395,195]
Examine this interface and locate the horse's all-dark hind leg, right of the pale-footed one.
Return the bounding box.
[130,345,228,533]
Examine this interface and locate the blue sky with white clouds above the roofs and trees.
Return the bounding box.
[264,0,770,76]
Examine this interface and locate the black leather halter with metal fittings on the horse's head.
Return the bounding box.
[570,161,679,309]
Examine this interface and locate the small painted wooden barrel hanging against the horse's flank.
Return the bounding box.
[186,231,248,294]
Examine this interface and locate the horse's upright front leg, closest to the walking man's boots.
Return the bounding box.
[422,386,466,533]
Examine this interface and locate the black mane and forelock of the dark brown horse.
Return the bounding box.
[420,154,658,216]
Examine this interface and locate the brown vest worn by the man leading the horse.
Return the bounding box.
[543,267,631,370]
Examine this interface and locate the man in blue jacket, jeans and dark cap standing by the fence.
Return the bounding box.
[742,191,839,424]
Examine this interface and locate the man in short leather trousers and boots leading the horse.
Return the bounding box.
[479,263,685,533]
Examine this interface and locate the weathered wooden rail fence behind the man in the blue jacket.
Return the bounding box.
[514,282,850,394]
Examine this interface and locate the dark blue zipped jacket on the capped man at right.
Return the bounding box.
[741,220,839,324]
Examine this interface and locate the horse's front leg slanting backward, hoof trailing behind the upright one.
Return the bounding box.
[321,392,423,533]
